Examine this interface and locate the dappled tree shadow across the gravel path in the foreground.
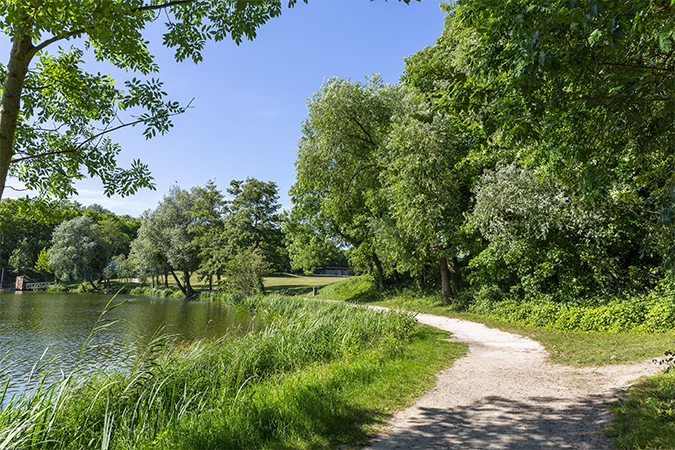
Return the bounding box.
[368,395,610,450]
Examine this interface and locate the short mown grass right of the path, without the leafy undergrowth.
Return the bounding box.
[310,280,675,450]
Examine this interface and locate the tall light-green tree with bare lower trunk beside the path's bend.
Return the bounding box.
[378,89,474,304]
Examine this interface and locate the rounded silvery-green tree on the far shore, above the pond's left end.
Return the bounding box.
[48,216,99,290]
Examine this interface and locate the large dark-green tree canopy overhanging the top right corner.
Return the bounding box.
[405,0,675,270]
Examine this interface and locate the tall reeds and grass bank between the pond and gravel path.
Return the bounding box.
[0,296,465,449]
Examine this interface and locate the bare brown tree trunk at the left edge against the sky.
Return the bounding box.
[0,33,34,198]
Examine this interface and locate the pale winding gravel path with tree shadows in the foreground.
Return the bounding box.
[368,314,659,450]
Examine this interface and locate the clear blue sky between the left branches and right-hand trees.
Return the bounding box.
[5,0,452,216]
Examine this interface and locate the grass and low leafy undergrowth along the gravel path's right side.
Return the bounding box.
[319,277,675,449]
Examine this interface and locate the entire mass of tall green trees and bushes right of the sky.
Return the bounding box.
[288,0,675,303]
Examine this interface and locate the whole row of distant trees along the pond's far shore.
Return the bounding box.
[0,178,290,297]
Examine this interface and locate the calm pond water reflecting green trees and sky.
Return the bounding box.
[0,292,260,393]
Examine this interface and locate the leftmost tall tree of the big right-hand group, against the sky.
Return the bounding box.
[290,77,403,284]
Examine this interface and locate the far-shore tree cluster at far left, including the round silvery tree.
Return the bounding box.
[0,198,140,285]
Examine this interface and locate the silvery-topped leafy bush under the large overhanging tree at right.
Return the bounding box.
[469,164,659,299]
